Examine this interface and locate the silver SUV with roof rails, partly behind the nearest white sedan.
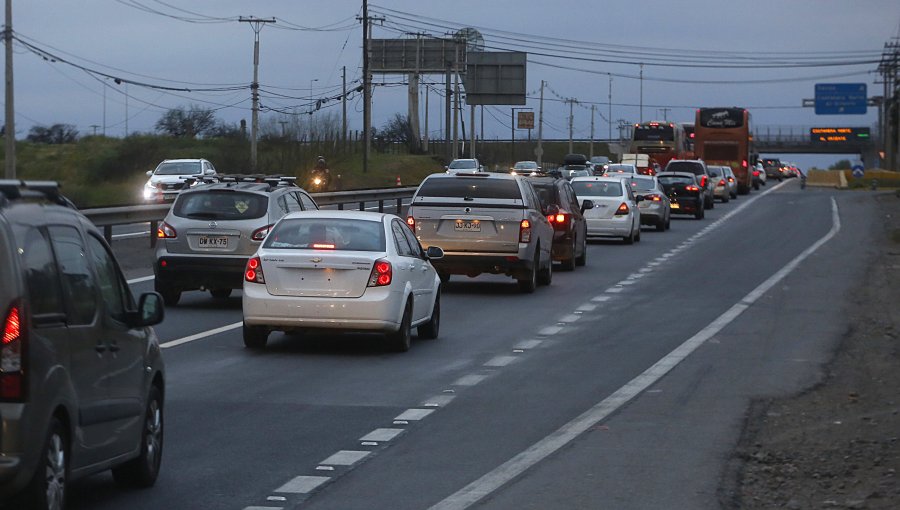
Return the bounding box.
[153,175,319,306]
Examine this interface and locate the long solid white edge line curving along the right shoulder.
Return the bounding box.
[429,195,841,510]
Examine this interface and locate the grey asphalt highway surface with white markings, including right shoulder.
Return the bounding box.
[70,180,873,510]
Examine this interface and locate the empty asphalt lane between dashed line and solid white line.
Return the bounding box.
[290,188,844,508]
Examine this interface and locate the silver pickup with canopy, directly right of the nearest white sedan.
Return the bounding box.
[407,173,559,292]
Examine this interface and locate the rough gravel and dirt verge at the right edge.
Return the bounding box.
[720,192,900,509]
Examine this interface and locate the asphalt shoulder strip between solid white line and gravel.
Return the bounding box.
[477,188,873,509]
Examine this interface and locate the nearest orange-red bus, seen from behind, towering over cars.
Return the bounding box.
[694,107,755,195]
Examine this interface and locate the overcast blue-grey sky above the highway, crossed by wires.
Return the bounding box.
[12,0,900,167]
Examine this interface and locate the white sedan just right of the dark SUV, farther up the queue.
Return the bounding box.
[572,175,641,244]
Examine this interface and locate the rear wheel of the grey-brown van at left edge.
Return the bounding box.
[16,417,69,510]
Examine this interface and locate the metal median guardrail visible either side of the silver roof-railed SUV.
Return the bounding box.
[81,186,417,247]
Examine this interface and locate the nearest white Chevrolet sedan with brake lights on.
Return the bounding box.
[243,211,444,351]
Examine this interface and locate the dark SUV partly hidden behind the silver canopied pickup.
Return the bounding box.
[527,174,594,271]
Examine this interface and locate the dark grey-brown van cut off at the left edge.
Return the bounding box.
[0,180,165,510]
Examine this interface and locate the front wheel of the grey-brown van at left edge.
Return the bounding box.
[112,386,163,487]
